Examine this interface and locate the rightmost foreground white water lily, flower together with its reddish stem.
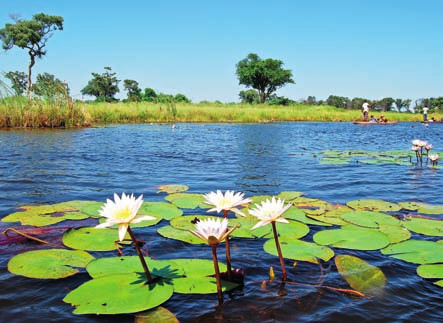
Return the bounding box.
[249,196,292,281]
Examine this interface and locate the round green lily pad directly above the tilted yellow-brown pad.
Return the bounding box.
[313,225,389,250]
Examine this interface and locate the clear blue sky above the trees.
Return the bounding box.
[0,0,443,102]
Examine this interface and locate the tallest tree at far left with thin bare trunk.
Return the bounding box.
[0,13,63,96]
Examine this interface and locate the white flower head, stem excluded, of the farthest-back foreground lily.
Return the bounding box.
[203,190,251,216]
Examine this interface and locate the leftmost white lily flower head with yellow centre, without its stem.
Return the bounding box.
[96,193,155,241]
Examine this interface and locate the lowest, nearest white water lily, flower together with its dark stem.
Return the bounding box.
[191,218,237,303]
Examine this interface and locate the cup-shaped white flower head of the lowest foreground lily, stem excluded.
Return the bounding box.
[190,218,237,245]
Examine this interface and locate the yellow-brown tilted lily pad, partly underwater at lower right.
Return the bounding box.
[335,255,386,296]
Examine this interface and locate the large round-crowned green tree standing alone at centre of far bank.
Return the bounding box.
[236,53,295,103]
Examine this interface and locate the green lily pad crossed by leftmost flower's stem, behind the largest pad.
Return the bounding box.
[86,256,184,279]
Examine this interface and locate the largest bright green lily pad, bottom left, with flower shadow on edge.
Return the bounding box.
[63,274,173,314]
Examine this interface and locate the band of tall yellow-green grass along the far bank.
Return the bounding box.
[0,96,443,129]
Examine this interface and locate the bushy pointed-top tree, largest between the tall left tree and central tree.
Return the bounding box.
[80,66,120,102]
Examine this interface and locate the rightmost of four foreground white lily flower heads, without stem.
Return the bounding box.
[249,197,292,230]
